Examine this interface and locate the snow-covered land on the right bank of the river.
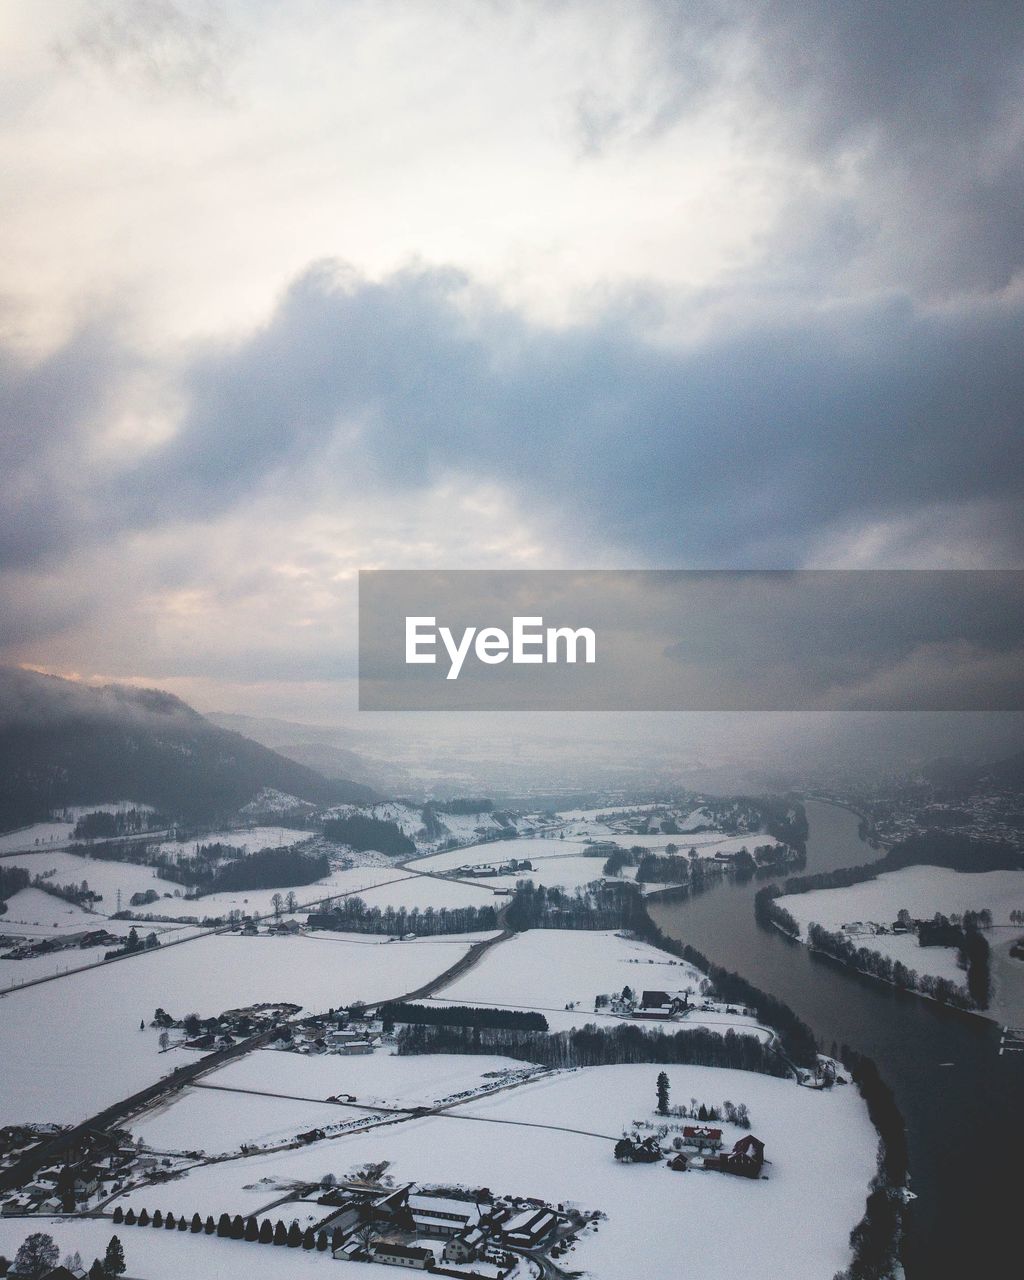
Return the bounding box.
[776,867,1024,997]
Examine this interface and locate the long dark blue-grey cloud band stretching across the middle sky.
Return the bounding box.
[111,268,1024,564]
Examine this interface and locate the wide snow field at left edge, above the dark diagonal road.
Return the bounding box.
[0,934,486,1124]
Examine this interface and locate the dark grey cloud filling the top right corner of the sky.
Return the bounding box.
[588,0,1024,291]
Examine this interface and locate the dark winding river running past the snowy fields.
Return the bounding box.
[650,800,1024,1280]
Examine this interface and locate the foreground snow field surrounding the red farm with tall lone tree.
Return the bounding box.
[110,1065,877,1280]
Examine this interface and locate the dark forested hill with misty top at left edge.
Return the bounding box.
[0,668,379,831]
